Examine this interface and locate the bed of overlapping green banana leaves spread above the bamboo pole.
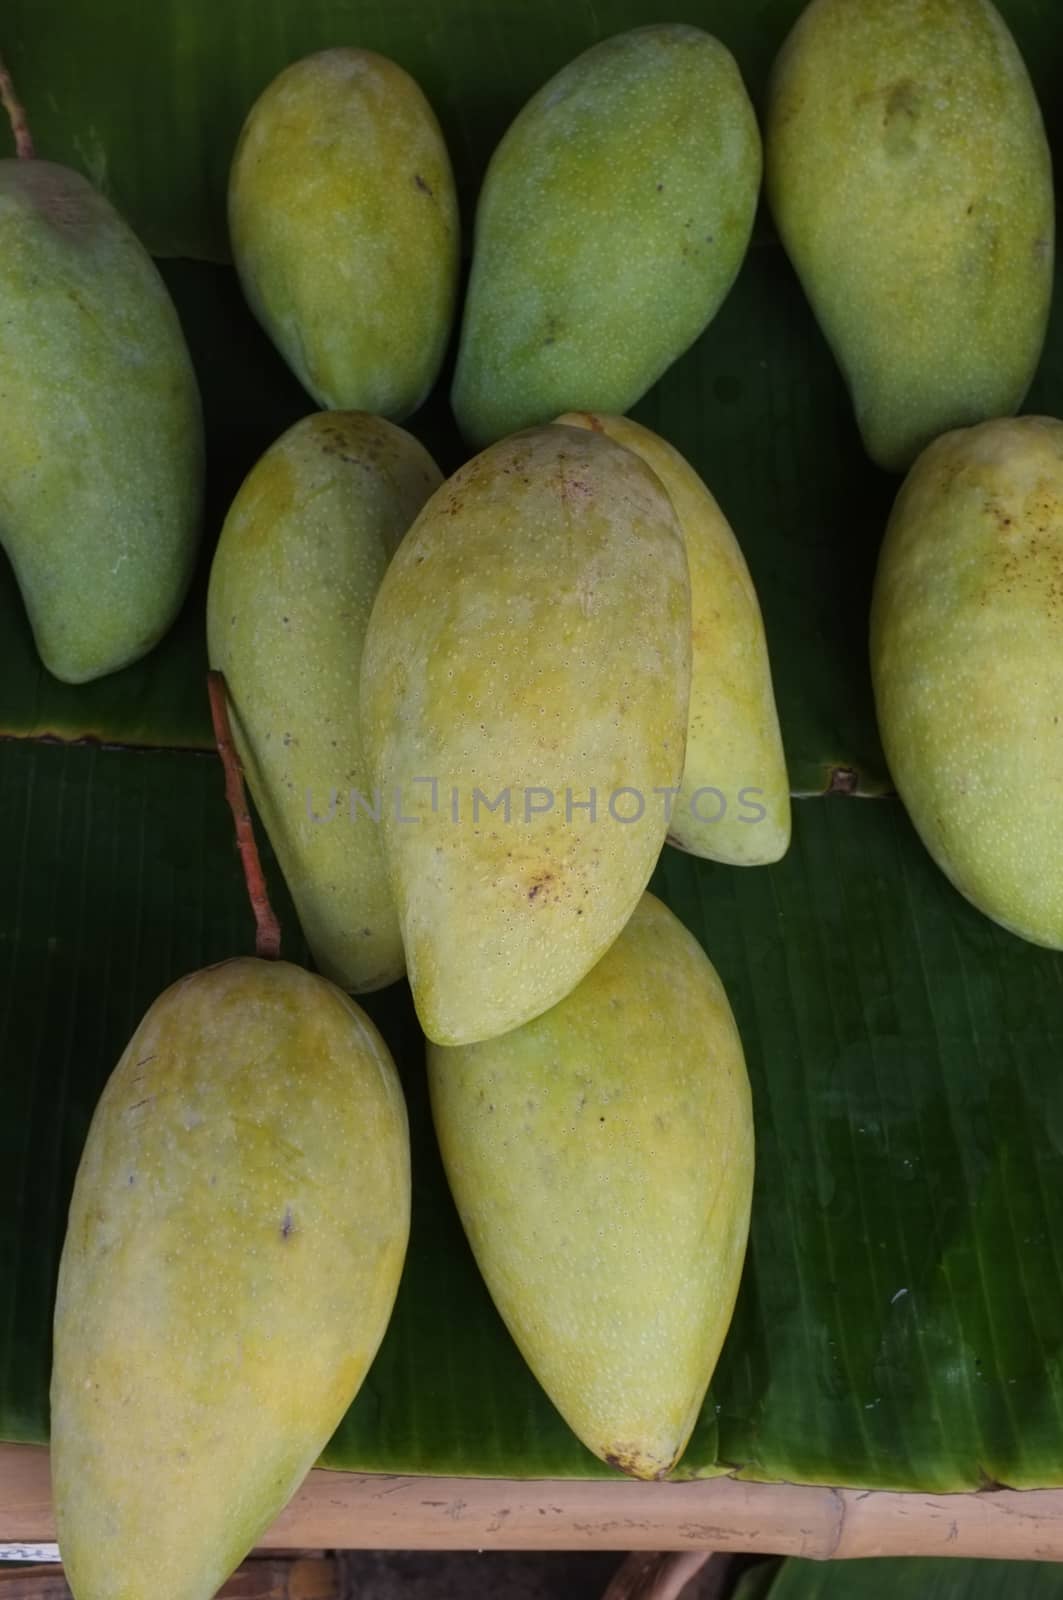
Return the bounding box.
[0,0,1063,1497]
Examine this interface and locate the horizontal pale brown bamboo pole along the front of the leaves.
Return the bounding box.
[0,1445,1063,1562]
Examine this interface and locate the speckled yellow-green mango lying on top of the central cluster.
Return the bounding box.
[362,427,690,1045]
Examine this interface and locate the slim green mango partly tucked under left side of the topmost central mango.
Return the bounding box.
[207,411,442,994]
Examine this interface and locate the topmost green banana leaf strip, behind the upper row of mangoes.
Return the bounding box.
[8,0,1063,261]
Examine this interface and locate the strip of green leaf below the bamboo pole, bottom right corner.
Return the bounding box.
[732,1555,1063,1600]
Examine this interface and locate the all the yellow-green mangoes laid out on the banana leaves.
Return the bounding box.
[0,0,1063,1600]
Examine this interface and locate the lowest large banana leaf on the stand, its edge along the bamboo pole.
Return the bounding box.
[0,741,1063,1491]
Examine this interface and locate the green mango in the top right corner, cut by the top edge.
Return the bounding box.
[765,0,1055,472]
